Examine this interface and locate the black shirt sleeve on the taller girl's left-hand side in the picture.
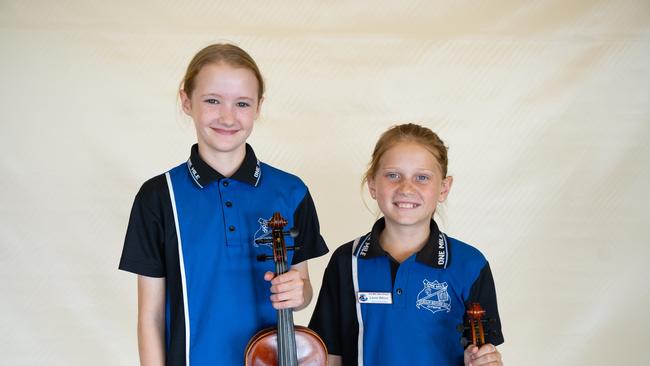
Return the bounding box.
[119,175,171,277]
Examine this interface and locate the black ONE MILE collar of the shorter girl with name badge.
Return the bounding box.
[354,217,450,268]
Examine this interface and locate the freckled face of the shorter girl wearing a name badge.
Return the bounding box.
[368,142,452,228]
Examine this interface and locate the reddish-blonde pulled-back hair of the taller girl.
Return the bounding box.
[180,43,264,101]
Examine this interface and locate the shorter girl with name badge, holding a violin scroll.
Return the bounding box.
[309,124,503,366]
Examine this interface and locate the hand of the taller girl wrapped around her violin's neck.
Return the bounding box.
[264,269,305,309]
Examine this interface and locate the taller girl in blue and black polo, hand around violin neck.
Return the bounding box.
[120,44,327,365]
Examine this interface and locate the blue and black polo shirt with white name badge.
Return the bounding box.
[309,218,503,366]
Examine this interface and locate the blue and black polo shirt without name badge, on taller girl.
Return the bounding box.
[119,145,328,365]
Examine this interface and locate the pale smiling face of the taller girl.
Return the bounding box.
[181,63,262,154]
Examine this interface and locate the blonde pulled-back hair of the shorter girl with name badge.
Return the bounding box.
[361,123,448,186]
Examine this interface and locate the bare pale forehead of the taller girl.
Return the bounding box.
[194,63,258,98]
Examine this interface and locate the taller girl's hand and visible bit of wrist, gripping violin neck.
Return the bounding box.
[264,261,313,310]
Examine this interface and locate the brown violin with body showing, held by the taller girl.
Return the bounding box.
[245,212,327,366]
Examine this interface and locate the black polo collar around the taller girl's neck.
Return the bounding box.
[187,144,262,188]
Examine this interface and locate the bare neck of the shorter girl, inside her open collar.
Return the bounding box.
[379,221,431,263]
